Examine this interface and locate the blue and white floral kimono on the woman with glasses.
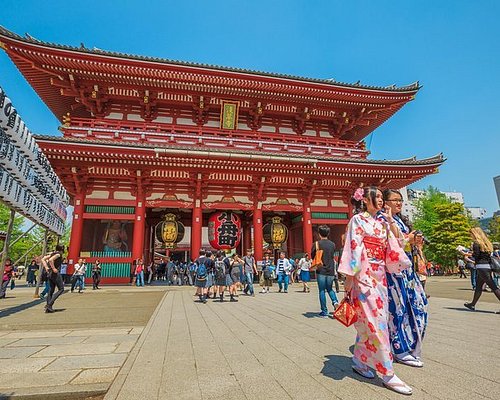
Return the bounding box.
[379,215,428,358]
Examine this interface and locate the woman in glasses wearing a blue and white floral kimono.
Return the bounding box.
[378,189,427,367]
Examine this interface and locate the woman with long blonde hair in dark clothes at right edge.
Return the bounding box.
[464,227,500,313]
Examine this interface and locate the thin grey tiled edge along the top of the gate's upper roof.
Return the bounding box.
[0,26,421,93]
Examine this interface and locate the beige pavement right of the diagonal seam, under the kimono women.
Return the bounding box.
[105,285,500,400]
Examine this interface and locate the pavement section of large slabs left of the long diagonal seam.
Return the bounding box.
[0,286,165,399]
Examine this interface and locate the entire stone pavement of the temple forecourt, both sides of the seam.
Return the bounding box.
[0,277,500,400]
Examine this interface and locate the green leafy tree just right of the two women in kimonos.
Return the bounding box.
[414,187,472,270]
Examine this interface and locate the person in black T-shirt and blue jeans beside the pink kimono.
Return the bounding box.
[311,225,339,318]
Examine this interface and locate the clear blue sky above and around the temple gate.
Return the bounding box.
[0,0,500,215]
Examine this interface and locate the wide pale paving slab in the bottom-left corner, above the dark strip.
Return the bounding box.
[0,370,80,389]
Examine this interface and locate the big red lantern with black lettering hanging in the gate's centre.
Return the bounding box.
[208,211,241,250]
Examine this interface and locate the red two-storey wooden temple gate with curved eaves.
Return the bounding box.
[0,28,443,282]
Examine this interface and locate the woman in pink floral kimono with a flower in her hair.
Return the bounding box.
[338,187,412,395]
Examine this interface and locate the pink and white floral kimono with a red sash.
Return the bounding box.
[339,212,411,375]
